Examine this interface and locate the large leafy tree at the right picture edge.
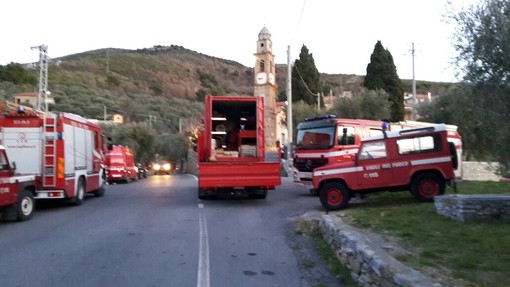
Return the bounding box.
[434,0,510,167]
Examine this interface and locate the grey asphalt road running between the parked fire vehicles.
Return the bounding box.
[0,175,339,287]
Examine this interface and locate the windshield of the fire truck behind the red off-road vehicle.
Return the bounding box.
[296,126,335,149]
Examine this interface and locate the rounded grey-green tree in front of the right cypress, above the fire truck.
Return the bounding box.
[328,89,390,120]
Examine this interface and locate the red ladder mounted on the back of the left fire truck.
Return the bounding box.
[42,113,57,187]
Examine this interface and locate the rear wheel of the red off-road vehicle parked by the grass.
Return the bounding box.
[411,173,445,202]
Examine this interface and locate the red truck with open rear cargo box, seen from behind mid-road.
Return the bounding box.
[197,95,281,199]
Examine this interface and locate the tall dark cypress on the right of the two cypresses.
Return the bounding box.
[363,41,404,121]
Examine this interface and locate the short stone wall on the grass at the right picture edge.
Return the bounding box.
[434,194,510,221]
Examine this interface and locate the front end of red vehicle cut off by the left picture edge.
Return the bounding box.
[0,145,35,221]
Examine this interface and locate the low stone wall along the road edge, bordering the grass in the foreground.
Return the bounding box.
[320,215,442,287]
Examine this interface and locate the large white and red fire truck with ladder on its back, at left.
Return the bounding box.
[0,103,105,205]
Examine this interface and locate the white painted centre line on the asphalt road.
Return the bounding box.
[197,203,210,287]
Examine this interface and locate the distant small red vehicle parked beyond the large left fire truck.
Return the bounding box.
[105,145,138,183]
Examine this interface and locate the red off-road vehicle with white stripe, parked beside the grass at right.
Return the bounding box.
[312,124,459,210]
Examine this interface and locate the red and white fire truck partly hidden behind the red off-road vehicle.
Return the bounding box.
[293,115,462,193]
